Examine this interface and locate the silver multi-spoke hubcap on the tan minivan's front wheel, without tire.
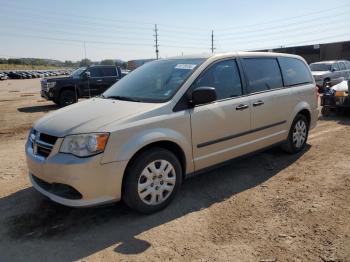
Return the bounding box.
[137,160,176,205]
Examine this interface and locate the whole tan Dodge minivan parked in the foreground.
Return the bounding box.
[26,53,318,213]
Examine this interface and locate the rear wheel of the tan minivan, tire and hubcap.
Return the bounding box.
[282,114,309,154]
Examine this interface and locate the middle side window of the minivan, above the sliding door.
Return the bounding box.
[243,58,283,93]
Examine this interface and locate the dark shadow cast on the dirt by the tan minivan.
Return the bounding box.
[0,145,310,261]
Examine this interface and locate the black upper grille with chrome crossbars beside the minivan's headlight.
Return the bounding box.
[30,130,57,158]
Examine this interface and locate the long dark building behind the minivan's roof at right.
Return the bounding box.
[259,41,350,63]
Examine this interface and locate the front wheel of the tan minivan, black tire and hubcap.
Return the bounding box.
[122,147,182,214]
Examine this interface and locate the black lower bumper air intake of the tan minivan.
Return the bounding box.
[32,175,83,200]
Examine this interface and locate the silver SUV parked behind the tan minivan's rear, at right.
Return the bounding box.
[310,60,350,91]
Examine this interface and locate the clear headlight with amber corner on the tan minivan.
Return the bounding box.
[60,133,109,157]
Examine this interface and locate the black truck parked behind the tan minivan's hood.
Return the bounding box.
[41,65,122,106]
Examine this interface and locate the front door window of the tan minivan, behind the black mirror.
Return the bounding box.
[194,60,242,100]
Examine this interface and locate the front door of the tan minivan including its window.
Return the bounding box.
[191,59,250,171]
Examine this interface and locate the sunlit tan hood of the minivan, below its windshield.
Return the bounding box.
[34,98,162,137]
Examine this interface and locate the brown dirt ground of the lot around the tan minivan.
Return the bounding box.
[0,79,350,261]
